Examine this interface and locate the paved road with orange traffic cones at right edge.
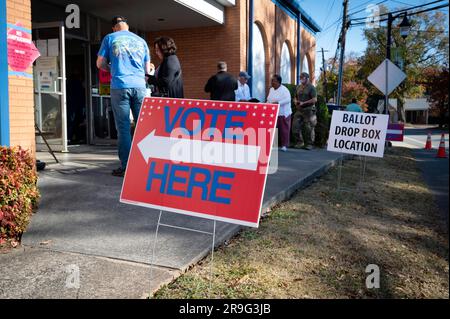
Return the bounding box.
[393,127,449,225]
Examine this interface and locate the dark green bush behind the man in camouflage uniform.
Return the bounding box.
[283,84,331,147]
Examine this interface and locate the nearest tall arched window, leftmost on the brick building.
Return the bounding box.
[252,23,266,102]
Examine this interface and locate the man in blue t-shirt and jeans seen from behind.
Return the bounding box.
[97,16,150,176]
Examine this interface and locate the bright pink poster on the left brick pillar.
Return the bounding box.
[7,23,40,72]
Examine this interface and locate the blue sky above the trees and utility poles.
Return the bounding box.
[300,0,448,76]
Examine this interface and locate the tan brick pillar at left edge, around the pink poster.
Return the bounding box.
[6,0,35,153]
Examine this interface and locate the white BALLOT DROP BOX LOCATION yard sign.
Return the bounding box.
[327,111,389,157]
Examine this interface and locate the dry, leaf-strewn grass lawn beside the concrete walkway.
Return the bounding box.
[154,148,449,298]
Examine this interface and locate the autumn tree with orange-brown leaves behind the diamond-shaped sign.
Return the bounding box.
[357,6,449,122]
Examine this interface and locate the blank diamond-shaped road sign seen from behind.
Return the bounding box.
[367,59,406,95]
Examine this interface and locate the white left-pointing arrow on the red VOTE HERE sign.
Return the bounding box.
[137,130,261,171]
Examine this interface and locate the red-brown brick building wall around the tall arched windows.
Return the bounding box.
[147,0,316,98]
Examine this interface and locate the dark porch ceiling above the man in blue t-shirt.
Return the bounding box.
[43,0,220,31]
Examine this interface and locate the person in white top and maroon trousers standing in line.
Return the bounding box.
[267,74,292,152]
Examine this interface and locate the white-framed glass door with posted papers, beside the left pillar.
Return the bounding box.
[33,22,67,152]
